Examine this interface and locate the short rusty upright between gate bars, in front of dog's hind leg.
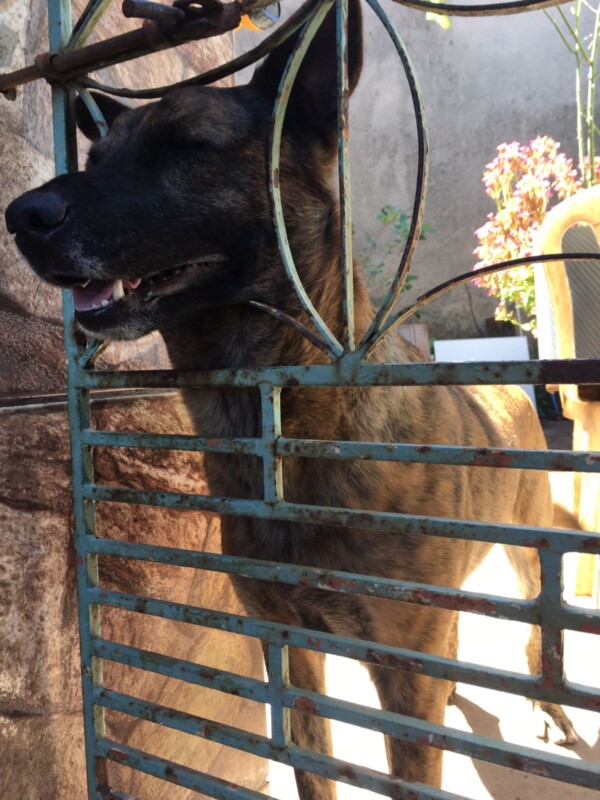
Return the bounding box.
[540,551,565,688]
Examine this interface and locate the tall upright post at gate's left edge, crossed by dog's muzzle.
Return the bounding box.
[48,0,105,800]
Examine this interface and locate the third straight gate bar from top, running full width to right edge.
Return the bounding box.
[83,483,600,554]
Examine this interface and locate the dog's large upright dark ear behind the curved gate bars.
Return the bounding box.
[251,0,363,144]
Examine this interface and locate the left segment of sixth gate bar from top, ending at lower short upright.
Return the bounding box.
[92,639,269,703]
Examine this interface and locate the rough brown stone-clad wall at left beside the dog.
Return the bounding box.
[0,0,265,800]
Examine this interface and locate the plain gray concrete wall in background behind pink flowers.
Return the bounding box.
[236,0,576,338]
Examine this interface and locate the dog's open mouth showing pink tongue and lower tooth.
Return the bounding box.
[71,254,225,313]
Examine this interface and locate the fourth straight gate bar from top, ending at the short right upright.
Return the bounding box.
[87,536,540,632]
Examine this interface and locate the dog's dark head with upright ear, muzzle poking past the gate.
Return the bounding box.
[6,0,362,339]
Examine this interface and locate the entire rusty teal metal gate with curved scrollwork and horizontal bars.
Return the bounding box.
[0,0,600,800]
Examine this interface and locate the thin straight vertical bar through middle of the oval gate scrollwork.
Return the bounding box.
[336,0,354,350]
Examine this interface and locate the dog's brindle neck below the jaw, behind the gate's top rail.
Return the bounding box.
[157,244,372,444]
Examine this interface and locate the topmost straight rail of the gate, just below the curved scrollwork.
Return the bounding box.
[78,354,600,389]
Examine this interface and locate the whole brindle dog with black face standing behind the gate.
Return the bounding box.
[6,4,576,800]
